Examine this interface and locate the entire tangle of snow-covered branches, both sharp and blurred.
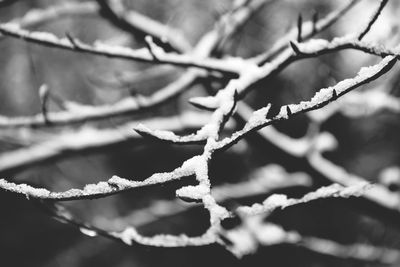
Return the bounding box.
[0,0,400,262]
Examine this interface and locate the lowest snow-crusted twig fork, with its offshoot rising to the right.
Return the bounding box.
[28,171,370,257]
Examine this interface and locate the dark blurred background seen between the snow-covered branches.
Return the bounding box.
[0,0,400,267]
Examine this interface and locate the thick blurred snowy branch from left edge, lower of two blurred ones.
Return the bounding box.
[0,112,216,176]
